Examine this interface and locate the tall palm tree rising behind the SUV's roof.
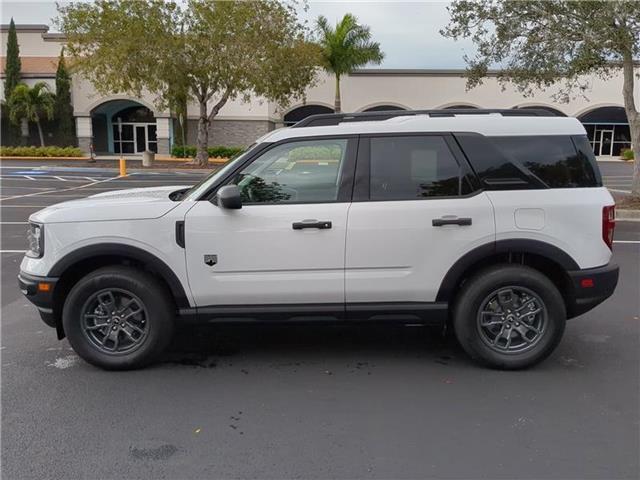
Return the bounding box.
[316,13,384,113]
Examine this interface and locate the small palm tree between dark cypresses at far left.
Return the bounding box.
[8,82,55,147]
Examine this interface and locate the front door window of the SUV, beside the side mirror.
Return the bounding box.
[229,139,348,204]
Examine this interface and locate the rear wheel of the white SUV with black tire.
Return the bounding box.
[453,264,567,370]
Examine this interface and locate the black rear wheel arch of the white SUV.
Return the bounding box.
[436,239,580,303]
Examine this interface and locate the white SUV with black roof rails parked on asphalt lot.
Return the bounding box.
[19,110,618,369]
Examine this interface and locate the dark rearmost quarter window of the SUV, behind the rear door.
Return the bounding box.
[490,135,599,188]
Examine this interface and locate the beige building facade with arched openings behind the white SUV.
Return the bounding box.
[0,25,640,156]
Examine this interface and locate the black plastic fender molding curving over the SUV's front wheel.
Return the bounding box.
[48,243,190,308]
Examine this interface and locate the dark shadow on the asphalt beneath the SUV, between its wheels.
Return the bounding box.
[161,324,468,368]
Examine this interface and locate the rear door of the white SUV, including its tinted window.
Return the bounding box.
[345,134,495,308]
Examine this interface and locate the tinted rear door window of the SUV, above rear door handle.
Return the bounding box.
[370,136,461,200]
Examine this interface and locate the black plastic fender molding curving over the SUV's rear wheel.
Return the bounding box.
[436,239,580,302]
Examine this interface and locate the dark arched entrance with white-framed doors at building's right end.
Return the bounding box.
[578,107,631,156]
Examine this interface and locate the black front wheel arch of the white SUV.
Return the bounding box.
[48,243,190,336]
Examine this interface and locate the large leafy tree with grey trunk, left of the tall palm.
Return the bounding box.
[59,0,318,163]
